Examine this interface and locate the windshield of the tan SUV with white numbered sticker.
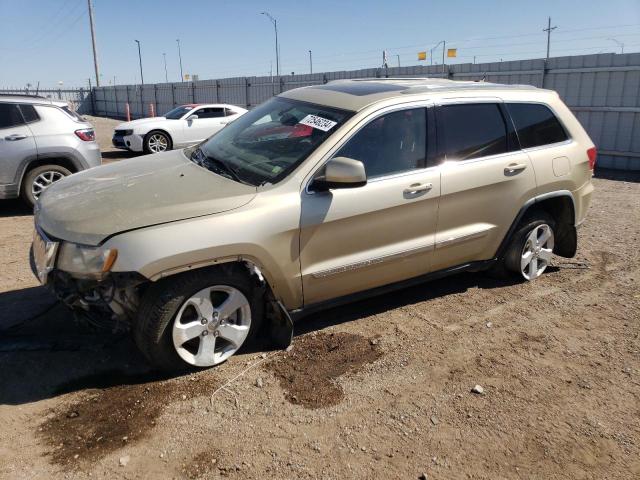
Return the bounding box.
[185,97,352,185]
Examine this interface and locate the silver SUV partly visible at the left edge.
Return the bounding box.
[0,95,102,206]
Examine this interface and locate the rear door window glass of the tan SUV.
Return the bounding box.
[438,103,508,160]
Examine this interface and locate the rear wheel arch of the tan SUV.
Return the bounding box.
[494,190,578,259]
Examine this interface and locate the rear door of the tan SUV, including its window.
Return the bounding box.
[433,98,536,270]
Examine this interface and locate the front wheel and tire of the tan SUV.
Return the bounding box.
[133,265,264,372]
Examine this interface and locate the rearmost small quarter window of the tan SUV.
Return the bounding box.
[507,103,568,148]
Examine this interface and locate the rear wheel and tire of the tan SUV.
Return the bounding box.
[489,210,556,281]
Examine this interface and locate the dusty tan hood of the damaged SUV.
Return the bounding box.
[36,150,256,245]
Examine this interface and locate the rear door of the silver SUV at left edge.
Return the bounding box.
[0,103,38,189]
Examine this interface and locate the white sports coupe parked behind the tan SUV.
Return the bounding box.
[112,103,247,153]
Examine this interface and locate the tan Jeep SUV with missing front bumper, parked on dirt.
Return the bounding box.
[32,79,596,370]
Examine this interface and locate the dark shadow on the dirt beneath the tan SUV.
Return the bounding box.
[0,268,548,405]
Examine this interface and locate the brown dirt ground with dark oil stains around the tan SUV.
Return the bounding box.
[0,127,640,479]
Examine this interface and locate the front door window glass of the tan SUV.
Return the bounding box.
[334,108,427,178]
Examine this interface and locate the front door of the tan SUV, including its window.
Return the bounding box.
[300,107,440,305]
